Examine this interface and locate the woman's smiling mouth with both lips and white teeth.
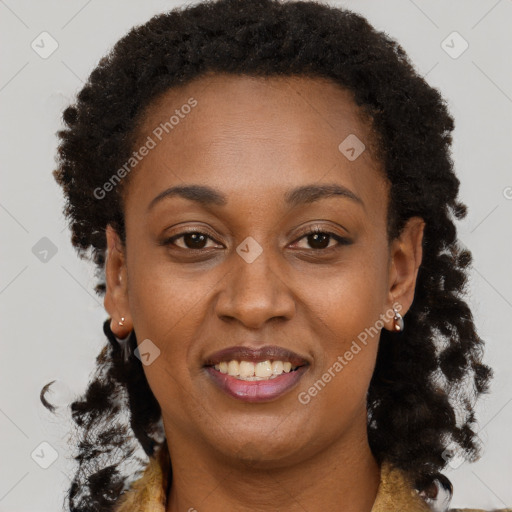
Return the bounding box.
[204,346,309,402]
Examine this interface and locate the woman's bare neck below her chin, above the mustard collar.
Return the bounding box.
[166,418,380,512]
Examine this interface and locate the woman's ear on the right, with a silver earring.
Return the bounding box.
[385,217,425,331]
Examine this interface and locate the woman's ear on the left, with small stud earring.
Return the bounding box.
[103,224,133,339]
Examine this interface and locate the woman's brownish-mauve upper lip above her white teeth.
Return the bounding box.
[205,345,309,366]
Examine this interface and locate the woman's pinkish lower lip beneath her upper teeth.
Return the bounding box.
[206,365,308,402]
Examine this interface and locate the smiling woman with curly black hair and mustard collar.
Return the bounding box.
[43,0,508,512]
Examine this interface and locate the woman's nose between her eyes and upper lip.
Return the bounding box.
[215,246,295,329]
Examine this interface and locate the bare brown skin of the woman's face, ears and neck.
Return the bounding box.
[105,74,424,512]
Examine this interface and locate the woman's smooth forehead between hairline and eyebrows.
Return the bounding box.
[125,73,384,221]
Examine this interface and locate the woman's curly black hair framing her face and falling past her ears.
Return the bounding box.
[41,0,492,512]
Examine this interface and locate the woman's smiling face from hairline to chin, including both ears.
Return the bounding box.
[105,74,422,466]
